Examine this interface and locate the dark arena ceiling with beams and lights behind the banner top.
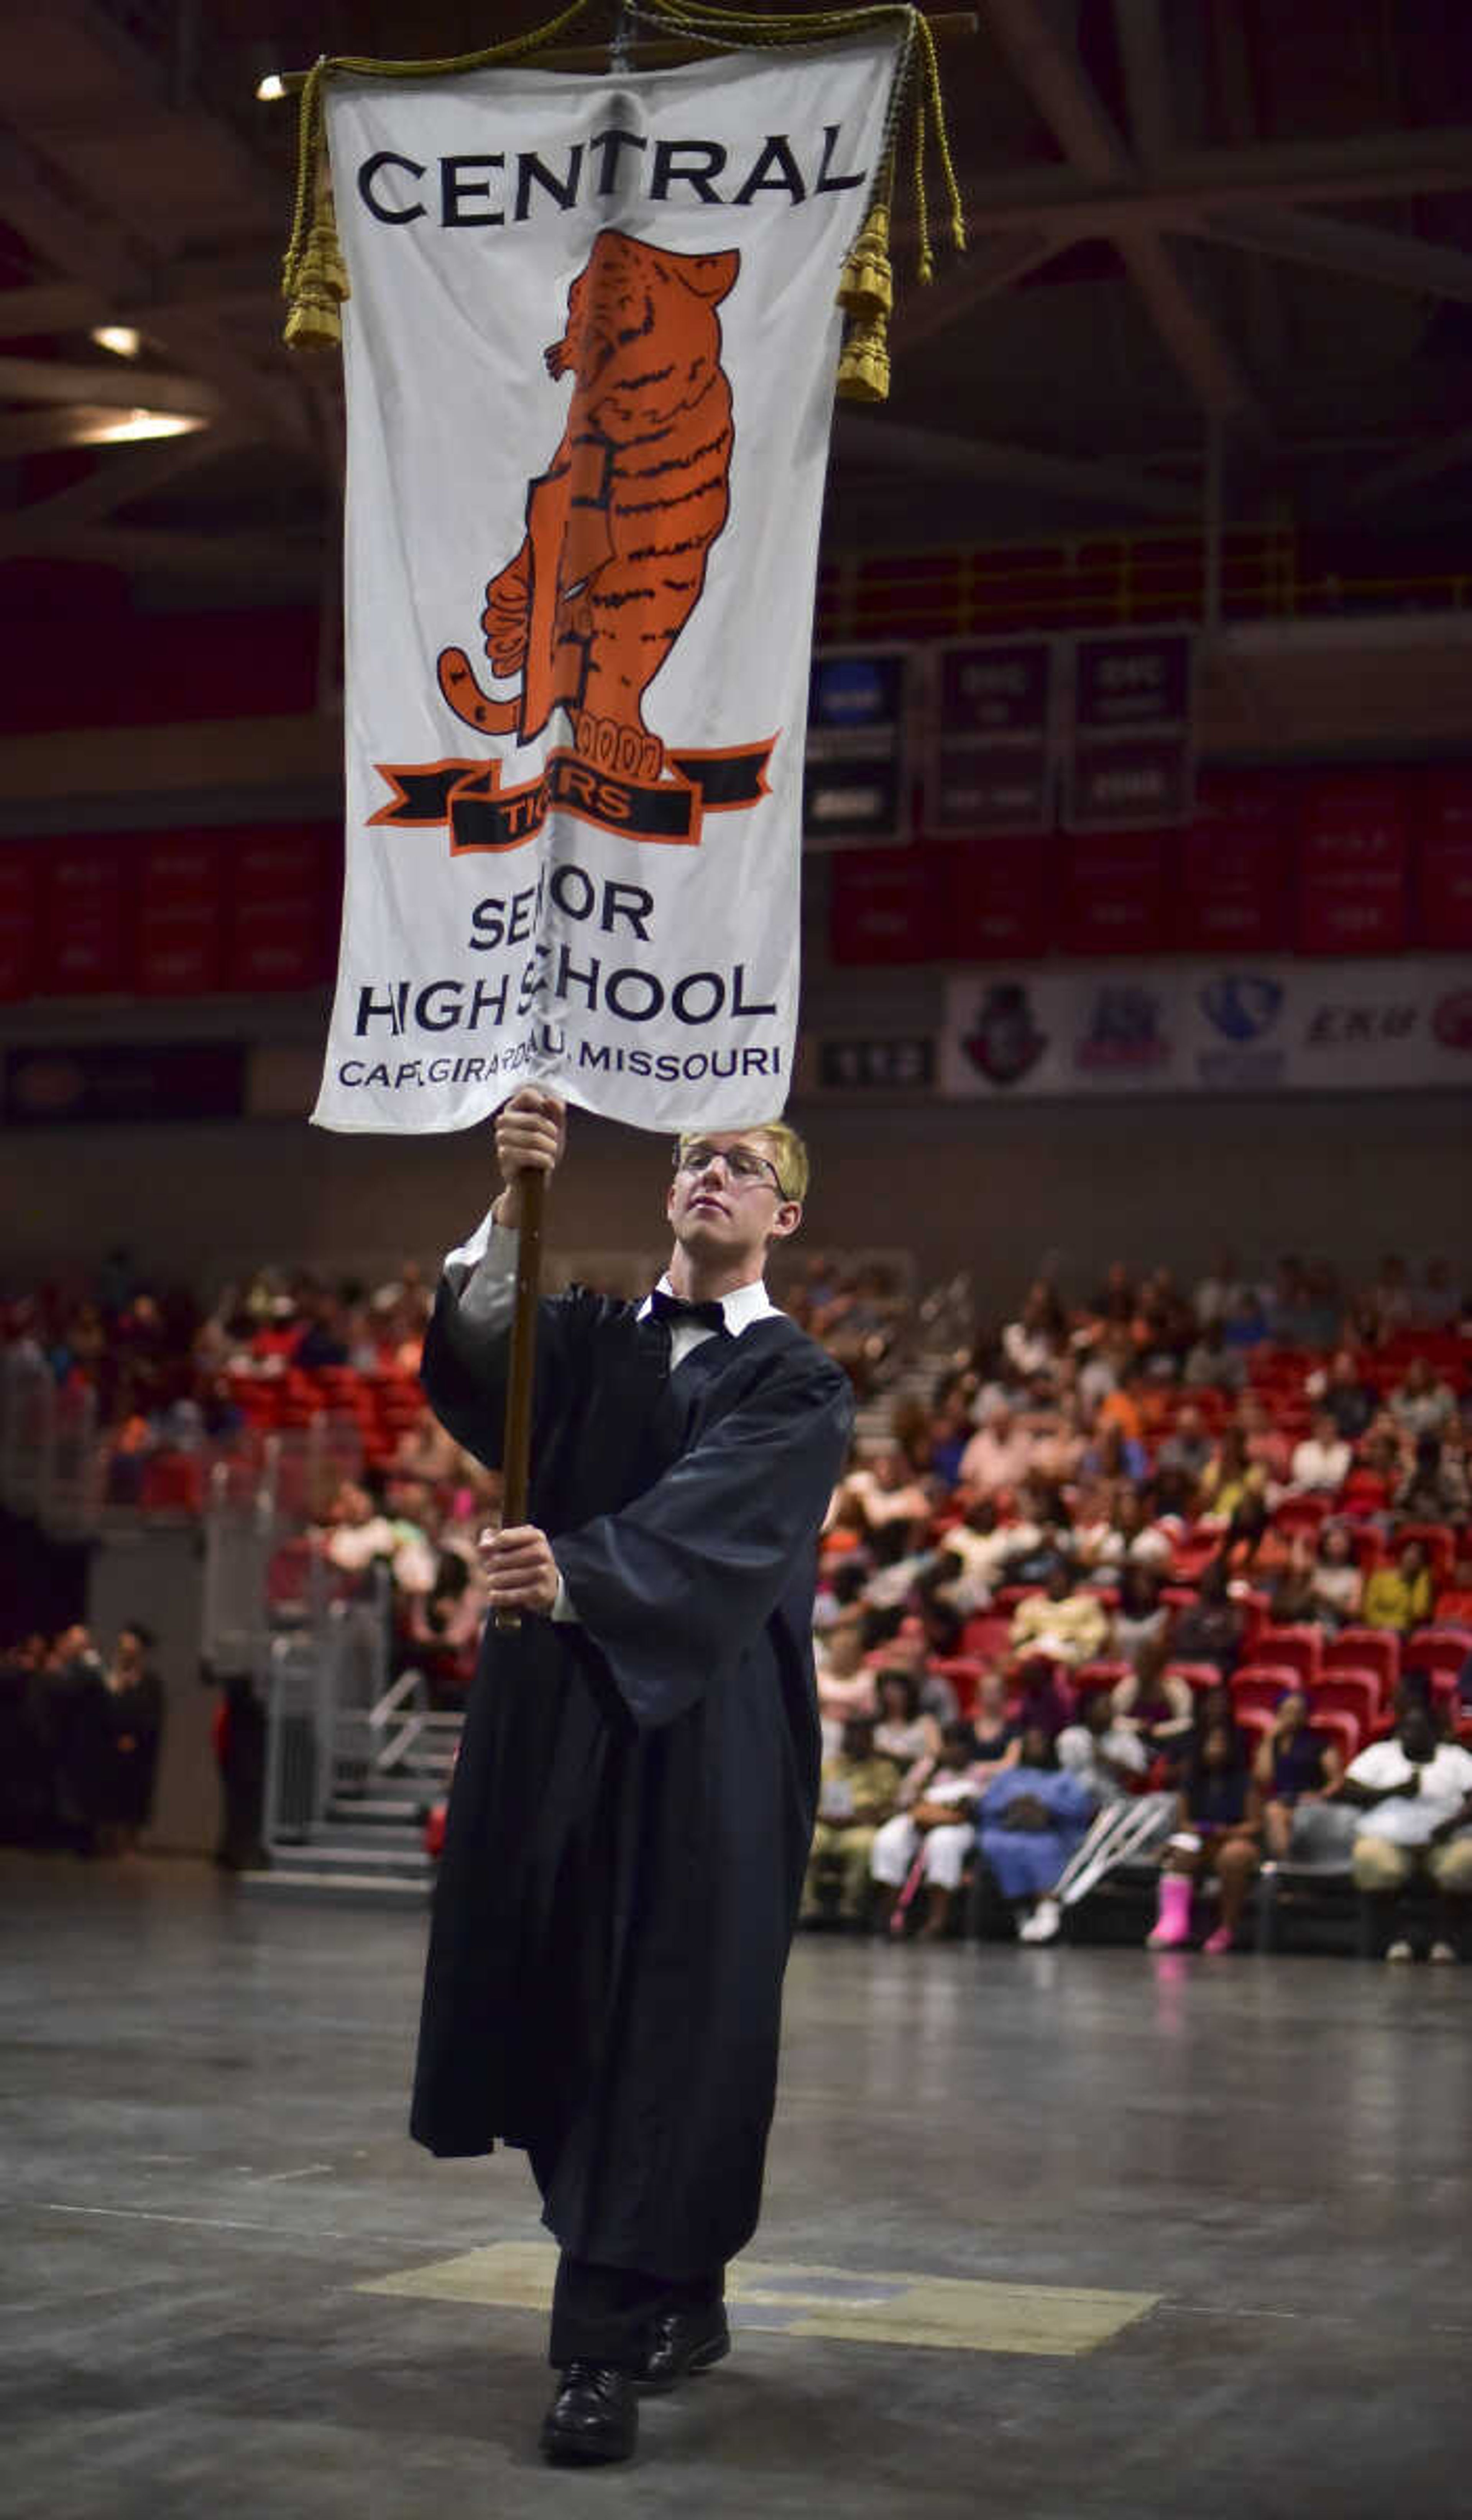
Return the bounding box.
[0,0,1472,602]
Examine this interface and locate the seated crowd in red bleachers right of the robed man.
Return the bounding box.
[809,1255,1472,1958]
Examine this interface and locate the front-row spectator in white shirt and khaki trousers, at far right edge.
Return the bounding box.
[1336,1691,1472,1961]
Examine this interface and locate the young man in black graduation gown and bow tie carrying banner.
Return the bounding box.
[413,1089,852,2462]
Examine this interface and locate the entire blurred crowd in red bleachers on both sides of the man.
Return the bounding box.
[0,1255,1472,1948]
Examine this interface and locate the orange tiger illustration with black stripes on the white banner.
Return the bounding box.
[439,229,741,779]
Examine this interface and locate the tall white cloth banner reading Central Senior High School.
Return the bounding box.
[315,40,895,1131]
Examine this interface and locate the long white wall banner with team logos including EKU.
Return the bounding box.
[940,955,1472,1101]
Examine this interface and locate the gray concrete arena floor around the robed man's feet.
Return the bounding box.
[0,1857,1472,2520]
